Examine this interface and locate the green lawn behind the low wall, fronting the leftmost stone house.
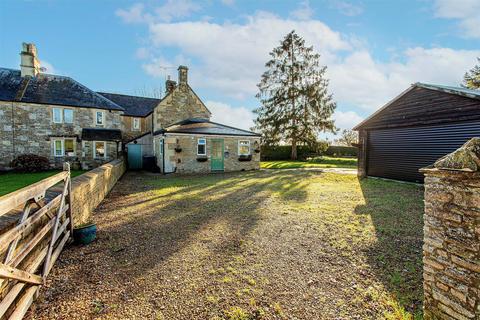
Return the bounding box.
[0,170,85,196]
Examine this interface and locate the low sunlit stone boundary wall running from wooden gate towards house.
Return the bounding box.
[72,159,126,226]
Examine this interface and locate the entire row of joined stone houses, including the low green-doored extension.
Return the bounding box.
[0,43,260,173]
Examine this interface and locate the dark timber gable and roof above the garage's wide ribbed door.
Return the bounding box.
[353,82,480,130]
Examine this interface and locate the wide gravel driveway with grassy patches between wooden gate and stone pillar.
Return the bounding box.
[35,170,423,320]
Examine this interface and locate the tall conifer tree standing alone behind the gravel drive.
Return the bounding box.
[254,31,336,160]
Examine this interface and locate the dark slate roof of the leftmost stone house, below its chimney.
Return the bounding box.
[0,68,123,111]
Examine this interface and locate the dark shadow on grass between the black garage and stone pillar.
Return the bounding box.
[355,178,424,317]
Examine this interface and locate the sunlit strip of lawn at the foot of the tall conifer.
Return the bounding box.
[260,157,357,169]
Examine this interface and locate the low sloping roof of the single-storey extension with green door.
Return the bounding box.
[154,118,260,137]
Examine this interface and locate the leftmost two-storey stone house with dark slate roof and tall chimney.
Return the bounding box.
[0,43,123,172]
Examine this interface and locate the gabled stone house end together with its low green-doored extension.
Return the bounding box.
[153,66,260,173]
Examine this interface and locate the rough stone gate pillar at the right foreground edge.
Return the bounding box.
[421,138,480,320]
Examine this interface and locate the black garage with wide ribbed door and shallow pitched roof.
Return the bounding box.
[354,83,480,182]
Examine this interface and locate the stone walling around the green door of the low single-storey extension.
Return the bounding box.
[157,135,260,173]
